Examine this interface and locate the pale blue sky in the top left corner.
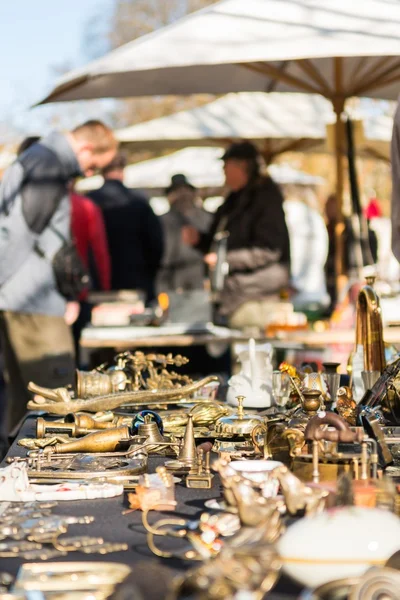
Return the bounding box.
[0,0,111,136]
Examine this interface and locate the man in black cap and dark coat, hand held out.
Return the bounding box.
[183,142,290,329]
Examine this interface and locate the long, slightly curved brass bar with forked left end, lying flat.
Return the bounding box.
[27,376,219,415]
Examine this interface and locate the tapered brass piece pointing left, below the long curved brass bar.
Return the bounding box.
[44,425,131,454]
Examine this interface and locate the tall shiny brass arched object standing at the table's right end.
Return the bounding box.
[355,277,386,373]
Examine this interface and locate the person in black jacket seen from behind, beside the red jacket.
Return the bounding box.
[88,154,163,303]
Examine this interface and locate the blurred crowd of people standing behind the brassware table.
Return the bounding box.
[0,120,380,446]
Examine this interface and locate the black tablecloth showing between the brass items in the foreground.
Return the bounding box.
[0,414,300,600]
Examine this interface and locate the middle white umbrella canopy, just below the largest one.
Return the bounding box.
[116,92,393,162]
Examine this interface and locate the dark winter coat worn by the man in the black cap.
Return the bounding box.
[199,177,290,315]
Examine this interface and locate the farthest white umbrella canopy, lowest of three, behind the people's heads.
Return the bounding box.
[78,148,324,191]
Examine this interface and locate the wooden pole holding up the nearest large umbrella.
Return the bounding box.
[332,58,346,299]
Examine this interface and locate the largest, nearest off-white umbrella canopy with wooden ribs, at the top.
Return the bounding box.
[42,0,400,103]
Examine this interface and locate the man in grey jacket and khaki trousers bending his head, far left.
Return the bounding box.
[0,121,117,430]
